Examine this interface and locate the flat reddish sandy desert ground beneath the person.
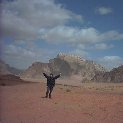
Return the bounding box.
[0,82,123,123]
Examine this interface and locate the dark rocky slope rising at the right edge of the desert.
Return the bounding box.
[92,65,123,83]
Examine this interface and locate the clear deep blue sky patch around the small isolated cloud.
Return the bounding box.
[57,0,123,31]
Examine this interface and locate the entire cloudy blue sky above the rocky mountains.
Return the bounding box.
[0,0,123,69]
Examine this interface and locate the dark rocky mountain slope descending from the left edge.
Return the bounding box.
[0,60,22,75]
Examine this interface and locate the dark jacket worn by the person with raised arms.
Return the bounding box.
[43,73,60,87]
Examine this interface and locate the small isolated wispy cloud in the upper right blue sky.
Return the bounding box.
[96,7,113,15]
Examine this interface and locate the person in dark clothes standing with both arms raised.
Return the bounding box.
[43,73,61,98]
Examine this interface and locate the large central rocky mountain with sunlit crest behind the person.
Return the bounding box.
[21,53,106,81]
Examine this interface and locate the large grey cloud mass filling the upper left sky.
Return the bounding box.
[1,0,83,40]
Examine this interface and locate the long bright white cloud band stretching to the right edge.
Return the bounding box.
[40,26,123,47]
